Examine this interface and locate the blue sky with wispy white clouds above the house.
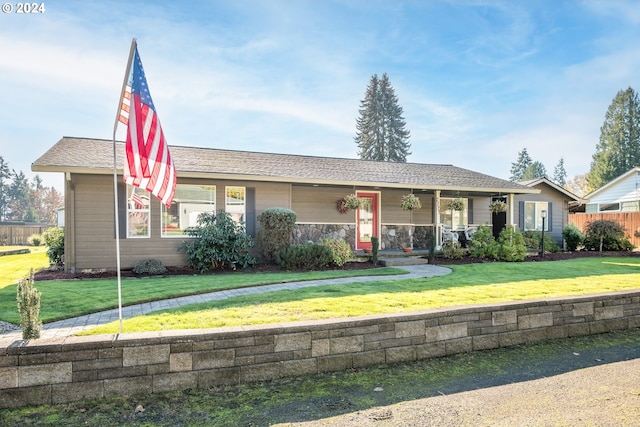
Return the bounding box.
[0,0,640,191]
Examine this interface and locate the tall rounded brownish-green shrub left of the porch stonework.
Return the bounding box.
[256,208,296,264]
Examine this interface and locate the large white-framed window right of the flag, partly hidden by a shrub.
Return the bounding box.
[162,184,216,237]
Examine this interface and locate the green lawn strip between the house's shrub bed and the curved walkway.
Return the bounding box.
[0,268,406,323]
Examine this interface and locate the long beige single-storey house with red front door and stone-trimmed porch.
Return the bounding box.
[32,137,540,271]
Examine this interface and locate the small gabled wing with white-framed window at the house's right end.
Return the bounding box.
[512,177,580,248]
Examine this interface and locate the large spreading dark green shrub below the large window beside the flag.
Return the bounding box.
[180,211,256,273]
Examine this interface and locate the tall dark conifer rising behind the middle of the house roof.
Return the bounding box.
[354,73,411,162]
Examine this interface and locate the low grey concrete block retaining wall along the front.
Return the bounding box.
[0,291,640,408]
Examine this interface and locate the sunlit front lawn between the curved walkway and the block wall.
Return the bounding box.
[87,258,640,334]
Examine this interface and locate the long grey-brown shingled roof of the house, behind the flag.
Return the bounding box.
[31,137,538,193]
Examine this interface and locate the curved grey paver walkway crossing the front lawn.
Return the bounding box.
[0,264,451,347]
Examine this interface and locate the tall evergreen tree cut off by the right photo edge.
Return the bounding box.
[589,87,640,190]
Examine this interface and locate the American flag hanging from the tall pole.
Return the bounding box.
[118,45,176,206]
